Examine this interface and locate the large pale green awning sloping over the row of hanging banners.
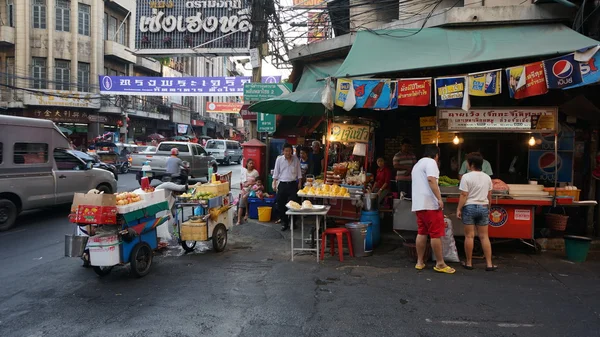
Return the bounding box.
[334,24,599,77]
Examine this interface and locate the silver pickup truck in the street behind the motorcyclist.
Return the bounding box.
[130,142,215,185]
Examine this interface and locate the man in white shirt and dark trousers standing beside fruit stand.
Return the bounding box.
[273,144,302,231]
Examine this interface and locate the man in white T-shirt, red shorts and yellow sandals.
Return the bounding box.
[412,145,456,274]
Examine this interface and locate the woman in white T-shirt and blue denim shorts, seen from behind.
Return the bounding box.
[456,152,498,271]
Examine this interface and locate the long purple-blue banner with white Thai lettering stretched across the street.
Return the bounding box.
[99,75,281,96]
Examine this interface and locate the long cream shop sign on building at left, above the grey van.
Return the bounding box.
[23,90,100,109]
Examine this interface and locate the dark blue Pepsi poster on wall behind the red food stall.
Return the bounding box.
[529,150,573,183]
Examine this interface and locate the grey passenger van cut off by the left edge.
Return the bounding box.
[0,115,117,231]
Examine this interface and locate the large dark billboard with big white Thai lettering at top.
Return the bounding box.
[135,0,252,55]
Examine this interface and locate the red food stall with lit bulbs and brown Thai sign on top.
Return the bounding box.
[394,107,596,248]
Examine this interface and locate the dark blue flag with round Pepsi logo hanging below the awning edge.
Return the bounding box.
[543,54,582,89]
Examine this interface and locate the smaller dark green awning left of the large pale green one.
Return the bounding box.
[249,60,343,116]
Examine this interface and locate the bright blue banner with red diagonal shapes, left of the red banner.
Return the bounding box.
[352,79,398,110]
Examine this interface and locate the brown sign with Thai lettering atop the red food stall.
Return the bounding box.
[438,107,557,132]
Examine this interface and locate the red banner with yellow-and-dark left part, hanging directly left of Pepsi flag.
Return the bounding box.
[506,62,548,99]
